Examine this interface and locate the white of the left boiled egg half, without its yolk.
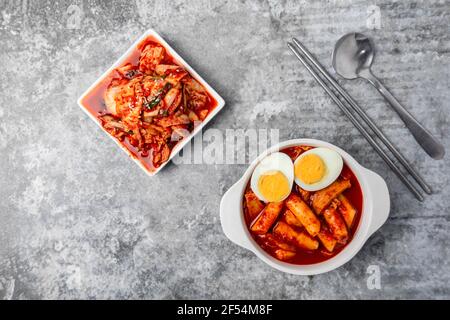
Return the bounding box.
[250,152,294,203]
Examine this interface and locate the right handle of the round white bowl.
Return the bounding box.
[365,169,391,235]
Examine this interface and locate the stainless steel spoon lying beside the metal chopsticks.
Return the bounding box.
[332,33,445,159]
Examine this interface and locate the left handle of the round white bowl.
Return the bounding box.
[220,179,252,250]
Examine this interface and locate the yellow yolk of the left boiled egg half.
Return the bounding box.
[258,170,291,202]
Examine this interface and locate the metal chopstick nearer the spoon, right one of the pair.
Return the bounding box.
[292,38,432,194]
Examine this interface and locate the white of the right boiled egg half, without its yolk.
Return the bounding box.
[294,147,344,191]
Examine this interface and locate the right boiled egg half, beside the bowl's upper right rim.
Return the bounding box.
[294,147,344,191]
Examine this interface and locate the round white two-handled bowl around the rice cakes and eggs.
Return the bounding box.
[220,139,390,275]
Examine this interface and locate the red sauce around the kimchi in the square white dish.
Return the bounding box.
[81,36,217,171]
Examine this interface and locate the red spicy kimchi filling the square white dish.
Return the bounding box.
[80,38,217,171]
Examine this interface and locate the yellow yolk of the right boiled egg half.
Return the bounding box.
[294,153,325,184]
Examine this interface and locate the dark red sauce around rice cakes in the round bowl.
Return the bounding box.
[243,146,363,265]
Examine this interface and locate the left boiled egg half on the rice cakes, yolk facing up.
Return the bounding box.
[250,152,294,202]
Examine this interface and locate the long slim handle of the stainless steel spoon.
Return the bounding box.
[359,69,445,160]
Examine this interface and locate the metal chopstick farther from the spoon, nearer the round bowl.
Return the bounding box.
[288,42,424,201]
